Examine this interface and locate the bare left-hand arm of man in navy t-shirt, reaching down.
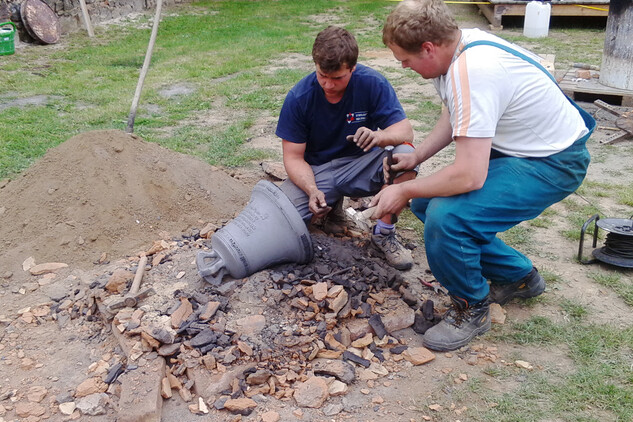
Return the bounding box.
[282,139,331,217]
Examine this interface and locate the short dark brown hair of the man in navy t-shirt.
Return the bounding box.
[312,26,358,73]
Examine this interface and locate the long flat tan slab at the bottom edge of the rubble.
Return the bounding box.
[117,357,165,422]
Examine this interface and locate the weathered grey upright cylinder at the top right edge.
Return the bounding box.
[600,0,633,90]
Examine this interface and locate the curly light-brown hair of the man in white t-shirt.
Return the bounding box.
[382,0,459,53]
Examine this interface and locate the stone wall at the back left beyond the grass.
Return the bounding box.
[0,0,186,42]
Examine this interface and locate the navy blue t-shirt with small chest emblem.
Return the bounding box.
[275,64,406,165]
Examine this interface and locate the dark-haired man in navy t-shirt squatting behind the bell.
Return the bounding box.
[276,26,417,270]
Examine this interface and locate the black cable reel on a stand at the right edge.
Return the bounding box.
[578,214,633,268]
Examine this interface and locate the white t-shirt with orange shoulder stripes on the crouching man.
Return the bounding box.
[432,29,588,157]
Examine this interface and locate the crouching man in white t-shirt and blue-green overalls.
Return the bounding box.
[370,0,595,351]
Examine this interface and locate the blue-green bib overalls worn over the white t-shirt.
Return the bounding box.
[411,41,596,304]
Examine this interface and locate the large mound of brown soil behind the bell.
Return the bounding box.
[0,130,251,273]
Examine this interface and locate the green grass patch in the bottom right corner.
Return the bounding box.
[474,316,633,421]
